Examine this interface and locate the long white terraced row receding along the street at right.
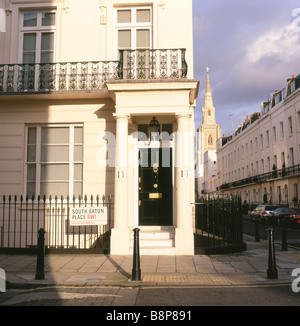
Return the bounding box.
[217,75,300,208]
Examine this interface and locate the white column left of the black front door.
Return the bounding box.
[111,115,129,255]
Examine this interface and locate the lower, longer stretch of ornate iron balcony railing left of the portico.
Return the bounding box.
[0,61,118,94]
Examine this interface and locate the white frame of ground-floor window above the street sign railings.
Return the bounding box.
[24,124,84,198]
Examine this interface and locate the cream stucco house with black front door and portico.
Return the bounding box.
[0,0,199,255]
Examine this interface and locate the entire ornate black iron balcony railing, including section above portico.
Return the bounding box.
[0,49,188,94]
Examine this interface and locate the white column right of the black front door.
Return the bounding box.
[175,114,194,255]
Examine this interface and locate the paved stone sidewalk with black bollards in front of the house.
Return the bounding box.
[0,235,300,289]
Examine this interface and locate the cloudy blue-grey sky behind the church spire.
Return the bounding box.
[193,0,300,135]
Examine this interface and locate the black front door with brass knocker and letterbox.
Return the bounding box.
[139,148,173,226]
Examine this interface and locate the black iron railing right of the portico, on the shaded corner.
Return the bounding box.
[195,197,245,254]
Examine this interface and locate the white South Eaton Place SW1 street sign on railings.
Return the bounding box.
[69,207,107,226]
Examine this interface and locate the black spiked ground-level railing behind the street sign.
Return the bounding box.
[0,196,112,251]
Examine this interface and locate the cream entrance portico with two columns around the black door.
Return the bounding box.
[107,80,198,255]
